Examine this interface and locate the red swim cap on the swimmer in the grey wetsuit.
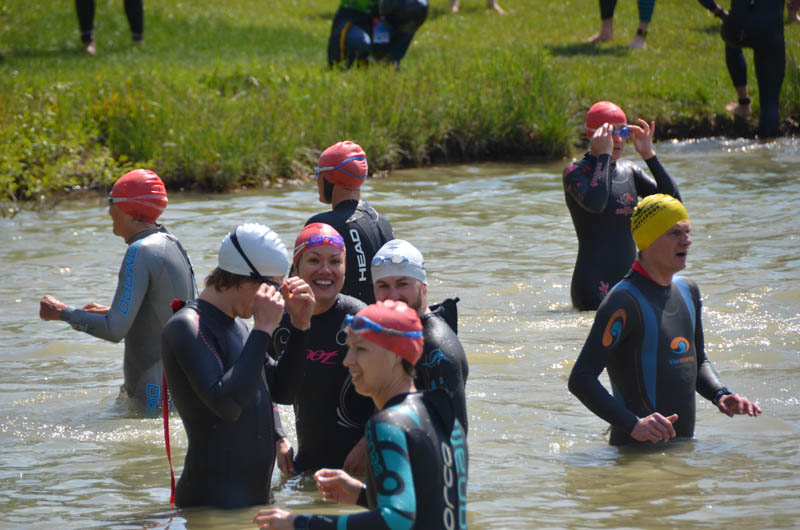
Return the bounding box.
[111,169,167,223]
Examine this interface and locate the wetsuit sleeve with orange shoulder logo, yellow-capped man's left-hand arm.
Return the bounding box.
[569,290,641,433]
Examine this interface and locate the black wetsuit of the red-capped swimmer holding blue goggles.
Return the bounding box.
[563,153,681,311]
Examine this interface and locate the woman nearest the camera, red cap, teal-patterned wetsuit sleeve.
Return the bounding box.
[253,300,468,530]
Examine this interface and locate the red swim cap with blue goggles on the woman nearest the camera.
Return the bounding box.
[348,300,423,365]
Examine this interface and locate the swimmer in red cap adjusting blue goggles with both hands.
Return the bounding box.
[563,101,680,311]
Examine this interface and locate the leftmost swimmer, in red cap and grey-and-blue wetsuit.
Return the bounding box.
[39,169,195,411]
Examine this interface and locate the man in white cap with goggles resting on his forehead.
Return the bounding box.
[372,239,469,433]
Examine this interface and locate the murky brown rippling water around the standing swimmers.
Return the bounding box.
[0,139,800,529]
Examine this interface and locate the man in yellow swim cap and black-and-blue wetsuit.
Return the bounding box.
[569,193,761,445]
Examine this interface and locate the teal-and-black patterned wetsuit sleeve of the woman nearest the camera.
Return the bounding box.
[296,420,417,530]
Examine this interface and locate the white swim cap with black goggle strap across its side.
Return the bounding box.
[218,223,289,279]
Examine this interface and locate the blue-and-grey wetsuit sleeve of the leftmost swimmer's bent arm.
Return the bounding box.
[60,242,153,342]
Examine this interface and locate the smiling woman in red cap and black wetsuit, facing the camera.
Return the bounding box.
[269,223,375,474]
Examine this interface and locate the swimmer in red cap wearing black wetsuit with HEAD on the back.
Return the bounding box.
[306,141,394,304]
